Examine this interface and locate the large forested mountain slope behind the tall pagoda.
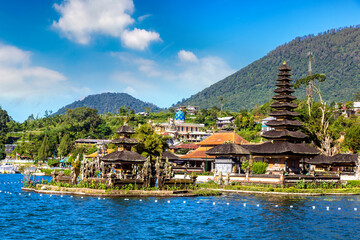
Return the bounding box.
[177,25,360,111]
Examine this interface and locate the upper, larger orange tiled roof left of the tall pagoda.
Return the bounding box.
[198,132,249,147]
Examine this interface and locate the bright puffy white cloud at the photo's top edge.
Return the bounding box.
[53,0,160,50]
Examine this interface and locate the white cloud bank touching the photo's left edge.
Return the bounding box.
[0,45,86,101]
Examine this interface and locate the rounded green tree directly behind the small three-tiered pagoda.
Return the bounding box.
[133,124,168,161]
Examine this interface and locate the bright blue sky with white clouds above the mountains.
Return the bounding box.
[0,0,360,122]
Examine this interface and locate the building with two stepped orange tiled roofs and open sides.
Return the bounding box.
[180,131,249,172]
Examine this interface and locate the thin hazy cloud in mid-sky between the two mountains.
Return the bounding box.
[112,51,235,95]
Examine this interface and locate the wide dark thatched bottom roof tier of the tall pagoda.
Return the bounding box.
[243,141,320,156]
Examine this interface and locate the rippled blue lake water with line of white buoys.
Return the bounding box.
[0,174,360,239]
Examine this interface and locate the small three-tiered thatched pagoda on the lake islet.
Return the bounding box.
[101,125,146,173]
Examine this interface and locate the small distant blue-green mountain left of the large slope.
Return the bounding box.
[55,93,161,114]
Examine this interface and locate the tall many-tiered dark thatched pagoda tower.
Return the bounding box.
[246,62,320,173]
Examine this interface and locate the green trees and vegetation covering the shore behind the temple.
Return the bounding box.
[0,92,360,161]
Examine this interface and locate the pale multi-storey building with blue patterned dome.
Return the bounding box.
[153,111,210,143]
